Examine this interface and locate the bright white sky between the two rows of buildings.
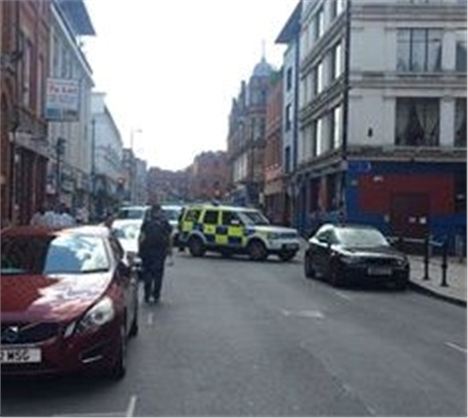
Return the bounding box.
[84,0,298,170]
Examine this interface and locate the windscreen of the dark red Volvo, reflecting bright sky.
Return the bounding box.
[1,235,110,276]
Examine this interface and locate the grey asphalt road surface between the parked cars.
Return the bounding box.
[1,250,467,416]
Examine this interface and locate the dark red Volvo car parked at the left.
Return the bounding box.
[0,227,138,378]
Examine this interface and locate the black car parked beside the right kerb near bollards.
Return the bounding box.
[304,224,409,289]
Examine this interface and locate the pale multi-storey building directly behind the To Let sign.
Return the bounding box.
[47,0,94,210]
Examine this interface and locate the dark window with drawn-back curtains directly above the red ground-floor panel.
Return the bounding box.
[395,98,439,146]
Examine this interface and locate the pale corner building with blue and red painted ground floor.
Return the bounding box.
[294,0,466,245]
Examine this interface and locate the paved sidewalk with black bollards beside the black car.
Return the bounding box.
[408,256,466,306]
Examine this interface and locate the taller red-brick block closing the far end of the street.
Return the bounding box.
[190,151,229,200]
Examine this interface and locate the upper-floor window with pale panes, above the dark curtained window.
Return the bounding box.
[397,29,442,72]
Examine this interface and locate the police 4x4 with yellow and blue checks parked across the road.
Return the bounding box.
[179,204,299,261]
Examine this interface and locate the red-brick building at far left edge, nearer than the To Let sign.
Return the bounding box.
[0,0,50,225]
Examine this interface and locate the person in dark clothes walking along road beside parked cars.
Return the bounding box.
[139,205,172,302]
